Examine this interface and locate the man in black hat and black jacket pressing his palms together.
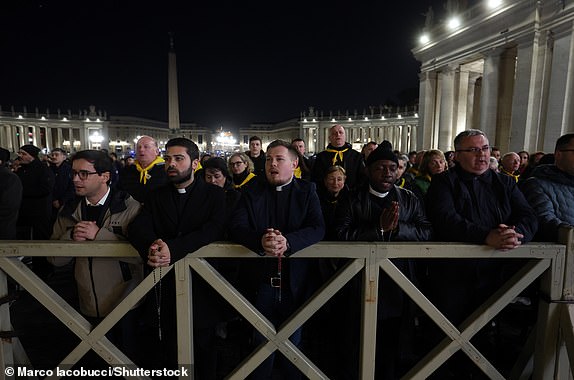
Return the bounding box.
[335,145,432,379]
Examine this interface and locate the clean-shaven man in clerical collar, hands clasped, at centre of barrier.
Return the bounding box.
[230,140,325,379]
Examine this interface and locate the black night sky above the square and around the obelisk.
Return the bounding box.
[0,0,444,129]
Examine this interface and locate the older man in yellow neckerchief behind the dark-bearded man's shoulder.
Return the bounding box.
[118,136,167,202]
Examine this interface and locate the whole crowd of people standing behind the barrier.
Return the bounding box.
[0,125,574,379]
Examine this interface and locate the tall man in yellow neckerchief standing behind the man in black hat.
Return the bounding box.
[311,124,365,190]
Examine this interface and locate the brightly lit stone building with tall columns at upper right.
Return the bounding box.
[412,0,574,152]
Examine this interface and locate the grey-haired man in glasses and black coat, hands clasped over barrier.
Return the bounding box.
[425,129,537,374]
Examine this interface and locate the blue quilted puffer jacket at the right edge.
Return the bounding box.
[521,165,574,242]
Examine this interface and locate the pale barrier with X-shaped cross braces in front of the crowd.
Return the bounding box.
[0,229,574,379]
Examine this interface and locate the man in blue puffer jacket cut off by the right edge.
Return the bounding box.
[522,133,574,241]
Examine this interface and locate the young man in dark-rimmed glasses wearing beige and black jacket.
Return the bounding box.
[50,150,143,358]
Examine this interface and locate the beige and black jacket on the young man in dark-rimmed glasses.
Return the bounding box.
[49,189,144,318]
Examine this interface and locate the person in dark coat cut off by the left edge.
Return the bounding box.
[0,148,22,240]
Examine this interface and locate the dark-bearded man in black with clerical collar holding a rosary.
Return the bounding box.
[129,137,225,379]
